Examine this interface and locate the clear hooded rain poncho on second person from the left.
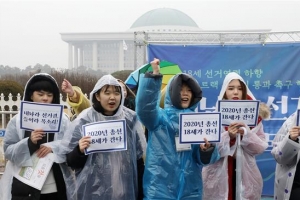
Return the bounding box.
[63,75,146,200]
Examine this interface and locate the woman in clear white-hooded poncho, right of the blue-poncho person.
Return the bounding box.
[202,72,270,200]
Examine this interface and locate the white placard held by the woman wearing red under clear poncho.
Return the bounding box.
[218,100,259,127]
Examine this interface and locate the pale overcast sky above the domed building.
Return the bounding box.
[0,0,300,68]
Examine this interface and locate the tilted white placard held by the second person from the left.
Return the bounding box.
[82,120,127,154]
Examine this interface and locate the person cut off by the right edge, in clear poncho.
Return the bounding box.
[271,110,300,200]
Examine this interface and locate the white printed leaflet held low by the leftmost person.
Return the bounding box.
[14,153,54,190]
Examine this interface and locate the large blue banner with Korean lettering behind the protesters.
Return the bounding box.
[147,43,300,195]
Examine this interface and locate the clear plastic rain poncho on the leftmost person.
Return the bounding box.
[0,73,74,200]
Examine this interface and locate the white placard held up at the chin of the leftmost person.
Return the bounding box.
[20,101,63,132]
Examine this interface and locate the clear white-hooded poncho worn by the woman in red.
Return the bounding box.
[202,72,268,200]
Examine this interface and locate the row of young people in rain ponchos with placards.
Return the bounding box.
[0,59,300,200]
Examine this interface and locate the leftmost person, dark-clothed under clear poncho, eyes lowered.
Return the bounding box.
[0,73,73,200]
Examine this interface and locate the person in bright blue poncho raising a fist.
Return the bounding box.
[136,59,219,200]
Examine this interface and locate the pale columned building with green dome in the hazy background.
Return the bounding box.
[61,8,270,74]
